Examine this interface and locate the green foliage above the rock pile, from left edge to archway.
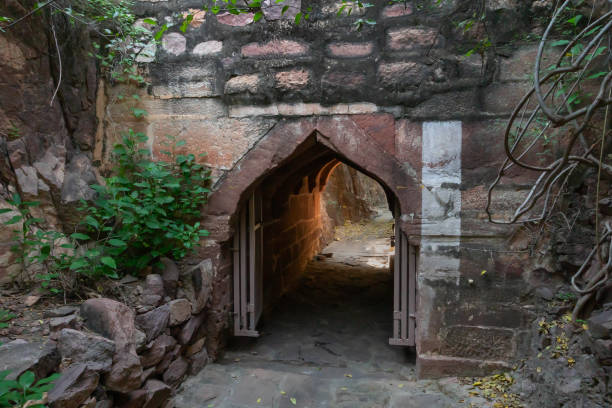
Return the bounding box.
[0,130,209,293]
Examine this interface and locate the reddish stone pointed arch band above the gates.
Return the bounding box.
[205,115,421,242]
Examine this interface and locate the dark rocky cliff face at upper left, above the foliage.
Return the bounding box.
[0,0,97,280]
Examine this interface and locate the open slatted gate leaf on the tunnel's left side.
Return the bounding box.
[233,192,263,337]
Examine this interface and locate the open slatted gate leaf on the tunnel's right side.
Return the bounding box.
[389,206,417,346]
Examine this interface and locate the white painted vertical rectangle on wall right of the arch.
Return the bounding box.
[419,121,462,279]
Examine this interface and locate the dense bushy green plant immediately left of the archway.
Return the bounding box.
[70,130,209,278]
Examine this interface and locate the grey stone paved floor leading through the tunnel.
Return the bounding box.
[174,223,498,408]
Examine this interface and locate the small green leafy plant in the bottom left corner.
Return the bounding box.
[0,371,60,408]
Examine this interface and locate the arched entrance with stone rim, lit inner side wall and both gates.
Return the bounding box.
[208,117,421,345]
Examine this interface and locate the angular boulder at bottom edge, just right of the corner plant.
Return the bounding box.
[48,364,100,408]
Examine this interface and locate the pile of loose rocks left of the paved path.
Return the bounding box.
[0,259,213,408]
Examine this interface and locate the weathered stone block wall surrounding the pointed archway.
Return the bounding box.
[96,1,556,376]
